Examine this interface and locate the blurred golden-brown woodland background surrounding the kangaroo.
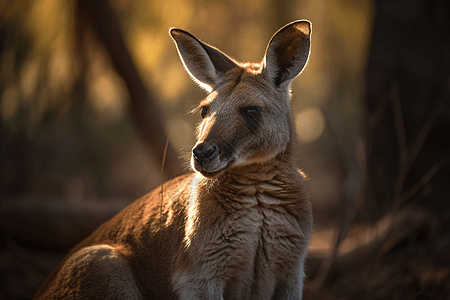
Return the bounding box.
[0,0,450,299]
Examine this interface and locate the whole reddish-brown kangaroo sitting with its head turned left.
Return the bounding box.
[35,20,312,300]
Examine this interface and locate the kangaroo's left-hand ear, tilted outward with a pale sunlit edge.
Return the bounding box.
[169,28,237,92]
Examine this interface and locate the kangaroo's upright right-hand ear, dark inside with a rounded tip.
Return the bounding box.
[263,20,311,86]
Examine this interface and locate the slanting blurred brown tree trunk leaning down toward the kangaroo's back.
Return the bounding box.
[76,0,183,179]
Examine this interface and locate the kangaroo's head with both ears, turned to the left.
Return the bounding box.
[170,21,311,177]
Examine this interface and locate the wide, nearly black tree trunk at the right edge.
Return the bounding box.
[364,0,450,221]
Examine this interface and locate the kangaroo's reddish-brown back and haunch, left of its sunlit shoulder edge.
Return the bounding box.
[36,174,193,299]
